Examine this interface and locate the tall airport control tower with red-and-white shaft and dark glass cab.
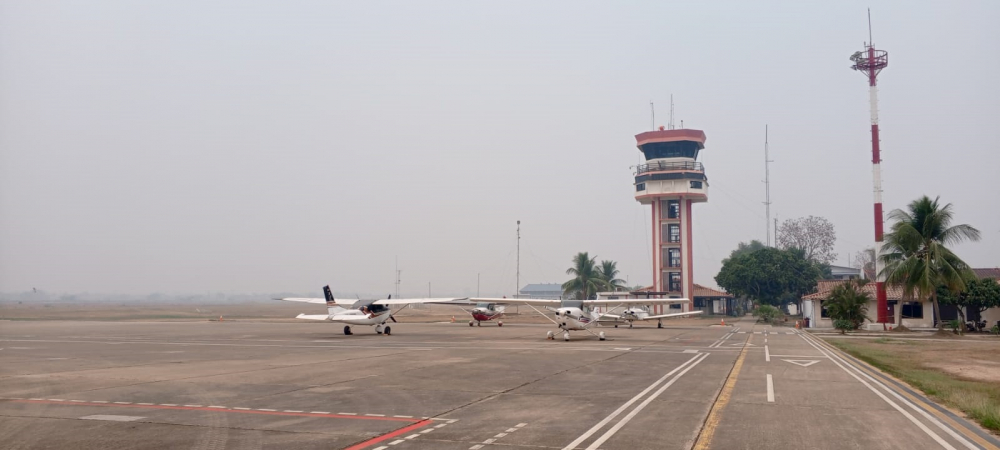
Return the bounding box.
[635,127,708,311]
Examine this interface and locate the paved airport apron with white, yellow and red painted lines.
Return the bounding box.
[0,320,998,450]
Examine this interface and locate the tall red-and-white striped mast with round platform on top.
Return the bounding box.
[851,22,891,323]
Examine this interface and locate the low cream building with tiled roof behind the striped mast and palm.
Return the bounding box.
[802,280,934,329]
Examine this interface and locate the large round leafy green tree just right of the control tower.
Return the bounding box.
[715,248,820,305]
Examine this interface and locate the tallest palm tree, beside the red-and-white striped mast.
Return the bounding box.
[879,195,979,328]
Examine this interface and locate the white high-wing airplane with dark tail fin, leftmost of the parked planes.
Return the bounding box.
[275,286,465,336]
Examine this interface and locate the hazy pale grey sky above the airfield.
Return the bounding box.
[0,0,1000,296]
